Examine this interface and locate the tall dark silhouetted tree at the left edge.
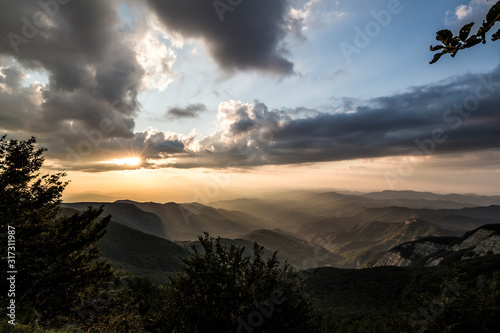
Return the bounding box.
[0,136,112,323]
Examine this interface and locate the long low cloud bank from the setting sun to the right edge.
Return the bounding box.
[20,67,500,172]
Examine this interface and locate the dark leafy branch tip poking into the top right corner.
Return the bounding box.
[430,1,500,64]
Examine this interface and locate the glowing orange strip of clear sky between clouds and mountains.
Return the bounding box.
[63,156,500,204]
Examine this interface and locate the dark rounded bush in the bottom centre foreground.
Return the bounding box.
[159,233,315,333]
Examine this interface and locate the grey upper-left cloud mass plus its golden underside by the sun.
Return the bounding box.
[0,0,197,171]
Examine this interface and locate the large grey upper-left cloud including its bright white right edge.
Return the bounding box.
[0,0,182,154]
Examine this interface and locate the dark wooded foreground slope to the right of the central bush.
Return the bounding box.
[305,255,500,333]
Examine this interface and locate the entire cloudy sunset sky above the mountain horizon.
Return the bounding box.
[0,0,500,203]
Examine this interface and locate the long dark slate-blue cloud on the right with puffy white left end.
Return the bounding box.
[193,67,500,165]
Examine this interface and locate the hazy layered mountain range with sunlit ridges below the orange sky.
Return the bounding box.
[63,191,500,280]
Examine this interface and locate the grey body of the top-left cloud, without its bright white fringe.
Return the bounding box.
[0,0,144,142]
